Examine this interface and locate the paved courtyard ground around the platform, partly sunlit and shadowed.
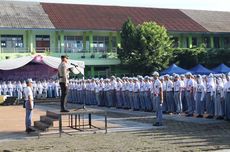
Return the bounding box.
[0,104,230,152]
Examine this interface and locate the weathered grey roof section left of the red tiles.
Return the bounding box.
[0,1,55,28]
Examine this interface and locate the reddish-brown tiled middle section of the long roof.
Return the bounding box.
[42,3,207,32]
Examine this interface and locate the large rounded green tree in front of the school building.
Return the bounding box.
[118,20,172,74]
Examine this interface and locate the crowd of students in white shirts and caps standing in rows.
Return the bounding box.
[0,73,230,120]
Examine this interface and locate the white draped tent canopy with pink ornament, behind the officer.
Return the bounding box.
[0,55,85,75]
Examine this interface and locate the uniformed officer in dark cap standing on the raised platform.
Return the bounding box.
[58,55,69,112]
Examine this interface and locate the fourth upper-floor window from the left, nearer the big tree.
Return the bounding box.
[93,36,109,52]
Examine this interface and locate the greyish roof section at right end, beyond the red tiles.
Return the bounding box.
[181,10,230,32]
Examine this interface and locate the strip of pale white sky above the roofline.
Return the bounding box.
[3,0,230,11]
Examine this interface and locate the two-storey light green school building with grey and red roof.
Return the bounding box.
[0,1,230,77]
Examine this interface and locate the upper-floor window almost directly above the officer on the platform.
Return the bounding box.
[64,36,83,53]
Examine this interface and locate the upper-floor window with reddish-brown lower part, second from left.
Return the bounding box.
[35,35,50,53]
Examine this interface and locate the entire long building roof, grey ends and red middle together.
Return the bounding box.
[0,1,230,33]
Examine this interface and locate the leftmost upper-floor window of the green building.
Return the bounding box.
[1,35,24,48]
